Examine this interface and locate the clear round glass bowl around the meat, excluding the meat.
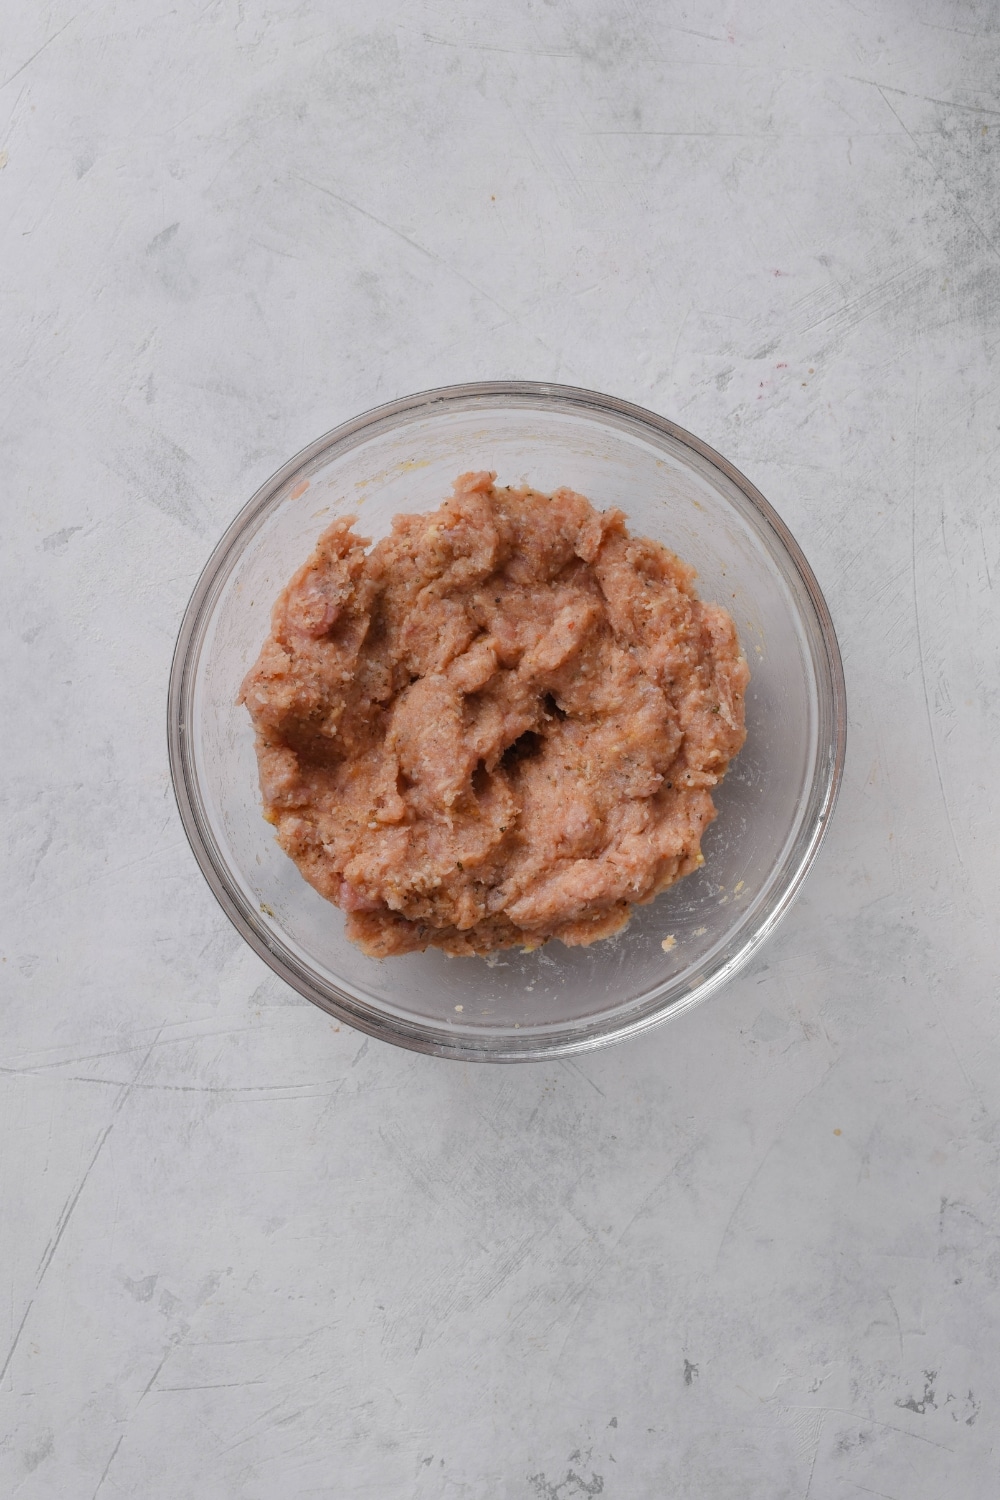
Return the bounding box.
[168,381,847,1062]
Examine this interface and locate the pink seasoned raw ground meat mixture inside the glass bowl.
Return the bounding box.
[240,474,748,957]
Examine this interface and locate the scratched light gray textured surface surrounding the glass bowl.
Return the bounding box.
[0,0,1000,1500]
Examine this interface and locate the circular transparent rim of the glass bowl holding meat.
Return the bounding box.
[166,380,847,1062]
